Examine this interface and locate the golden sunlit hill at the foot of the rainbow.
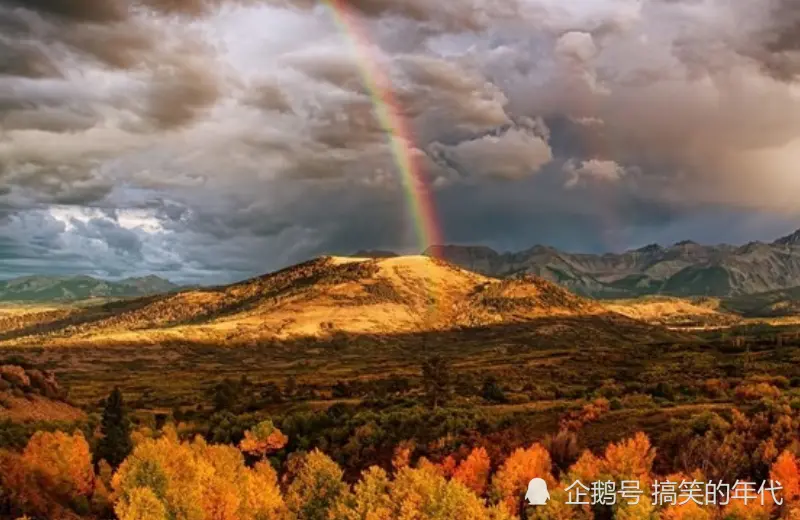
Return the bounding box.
[0,256,664,344]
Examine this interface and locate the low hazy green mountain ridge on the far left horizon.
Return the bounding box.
[0,275,178,302]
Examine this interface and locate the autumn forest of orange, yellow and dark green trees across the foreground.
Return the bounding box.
[0,328,800,520]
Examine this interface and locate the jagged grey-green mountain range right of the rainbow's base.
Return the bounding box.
[425,230,800,298]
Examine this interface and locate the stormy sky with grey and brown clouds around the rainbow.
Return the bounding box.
[0,0,800,283]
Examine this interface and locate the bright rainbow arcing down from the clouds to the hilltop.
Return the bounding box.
[322,0,443,251]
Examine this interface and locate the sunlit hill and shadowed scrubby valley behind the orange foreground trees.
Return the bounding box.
[0,255,800,511]
